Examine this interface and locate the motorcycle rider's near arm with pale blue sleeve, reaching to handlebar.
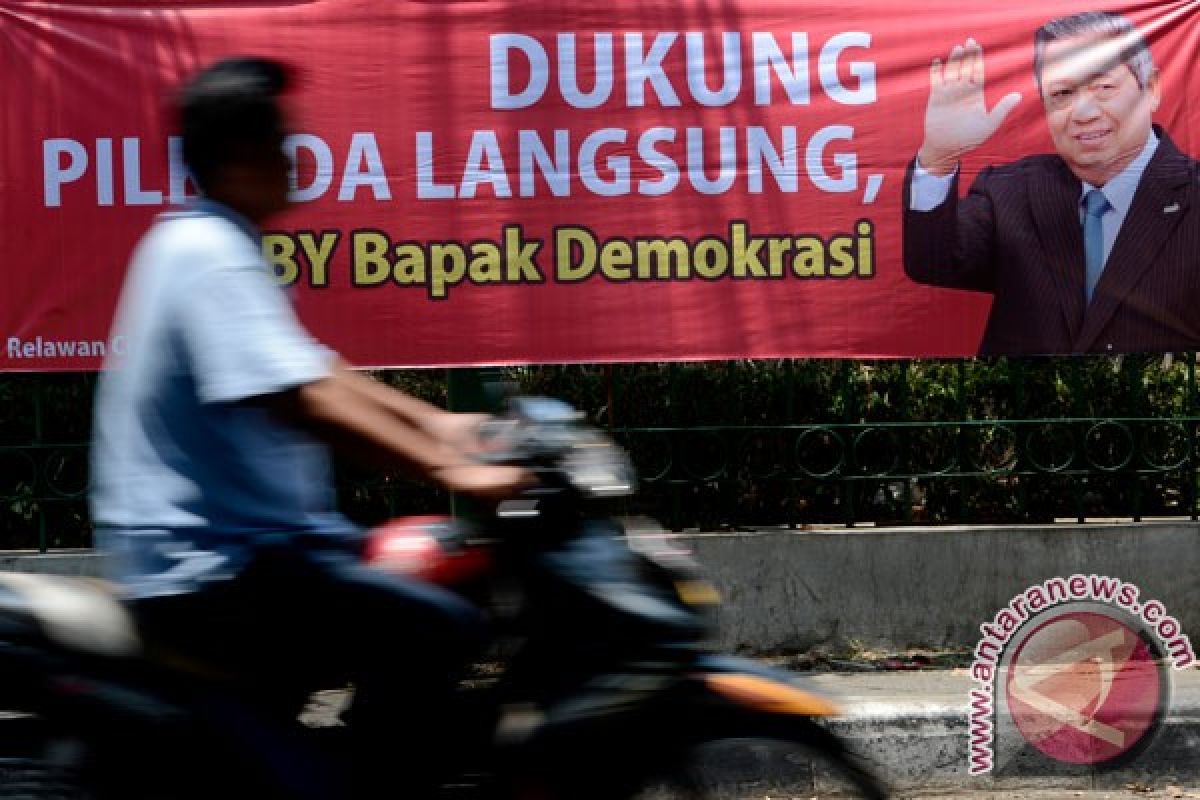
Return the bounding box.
[175,253,526,499]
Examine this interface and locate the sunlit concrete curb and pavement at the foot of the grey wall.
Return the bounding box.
[0,670,1200,800]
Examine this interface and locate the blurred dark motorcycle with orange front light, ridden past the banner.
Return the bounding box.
[0,397,887,800]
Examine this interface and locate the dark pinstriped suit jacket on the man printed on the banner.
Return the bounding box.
[904,127,1200,355]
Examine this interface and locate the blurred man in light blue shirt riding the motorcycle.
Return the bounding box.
[90,58,528,796]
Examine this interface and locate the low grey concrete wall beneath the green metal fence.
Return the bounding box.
[0,523,1200,652]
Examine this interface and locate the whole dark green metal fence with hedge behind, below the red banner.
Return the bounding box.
[0,354,1200,549]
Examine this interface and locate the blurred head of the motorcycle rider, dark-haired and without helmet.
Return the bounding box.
[178,58,290,223]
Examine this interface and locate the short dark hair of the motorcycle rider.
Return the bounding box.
[178,58,290,188]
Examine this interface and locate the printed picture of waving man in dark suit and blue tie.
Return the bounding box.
[904,12,1200,355]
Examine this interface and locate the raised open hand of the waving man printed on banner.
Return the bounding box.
[917,38,1021,175]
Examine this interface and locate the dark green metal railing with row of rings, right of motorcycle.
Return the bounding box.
[609,417,1200,528]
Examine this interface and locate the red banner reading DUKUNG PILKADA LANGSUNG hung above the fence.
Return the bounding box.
[0,0,1200,371]
